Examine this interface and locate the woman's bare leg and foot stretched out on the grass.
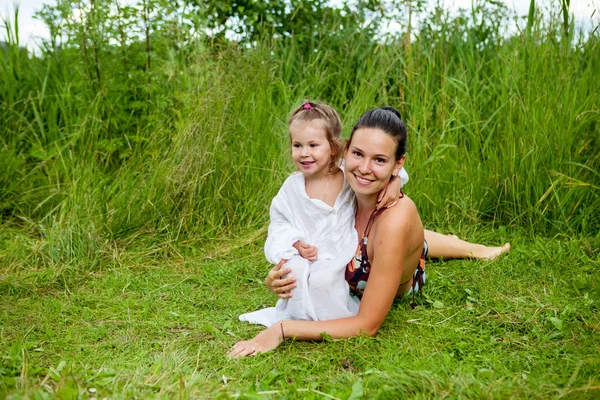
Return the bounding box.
[425,229,510,260]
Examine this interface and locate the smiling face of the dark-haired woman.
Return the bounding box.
[344,128,405,195]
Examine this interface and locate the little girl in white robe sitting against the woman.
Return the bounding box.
[240,102,408,327]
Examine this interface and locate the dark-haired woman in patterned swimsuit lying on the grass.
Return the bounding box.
[229,107,508,357]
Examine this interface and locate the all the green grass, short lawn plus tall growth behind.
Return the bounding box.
[0,0,600,399]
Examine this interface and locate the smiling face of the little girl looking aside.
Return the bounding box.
[290,120,333,177]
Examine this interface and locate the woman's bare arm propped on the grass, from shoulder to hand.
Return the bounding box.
[229,198,423,357]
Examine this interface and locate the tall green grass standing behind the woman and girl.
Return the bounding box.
[0,1,600,268]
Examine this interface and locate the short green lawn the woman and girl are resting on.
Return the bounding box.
[0,229,600,399]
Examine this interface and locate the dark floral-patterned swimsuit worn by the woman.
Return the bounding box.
[346,208,427,307]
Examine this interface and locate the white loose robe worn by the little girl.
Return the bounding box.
[239,169,408,327]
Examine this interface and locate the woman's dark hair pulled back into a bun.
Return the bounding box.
[348,106,407,161]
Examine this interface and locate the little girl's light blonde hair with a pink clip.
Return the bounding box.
[288,100,344,172]
